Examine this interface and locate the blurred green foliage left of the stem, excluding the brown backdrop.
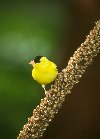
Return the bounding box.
[0,2,69,139]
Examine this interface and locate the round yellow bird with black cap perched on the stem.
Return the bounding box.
[29,56,58,91]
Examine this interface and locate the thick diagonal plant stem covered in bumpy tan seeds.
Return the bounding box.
[17,20,100,139]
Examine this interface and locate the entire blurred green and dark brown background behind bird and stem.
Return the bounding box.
[0,0,100,139]
